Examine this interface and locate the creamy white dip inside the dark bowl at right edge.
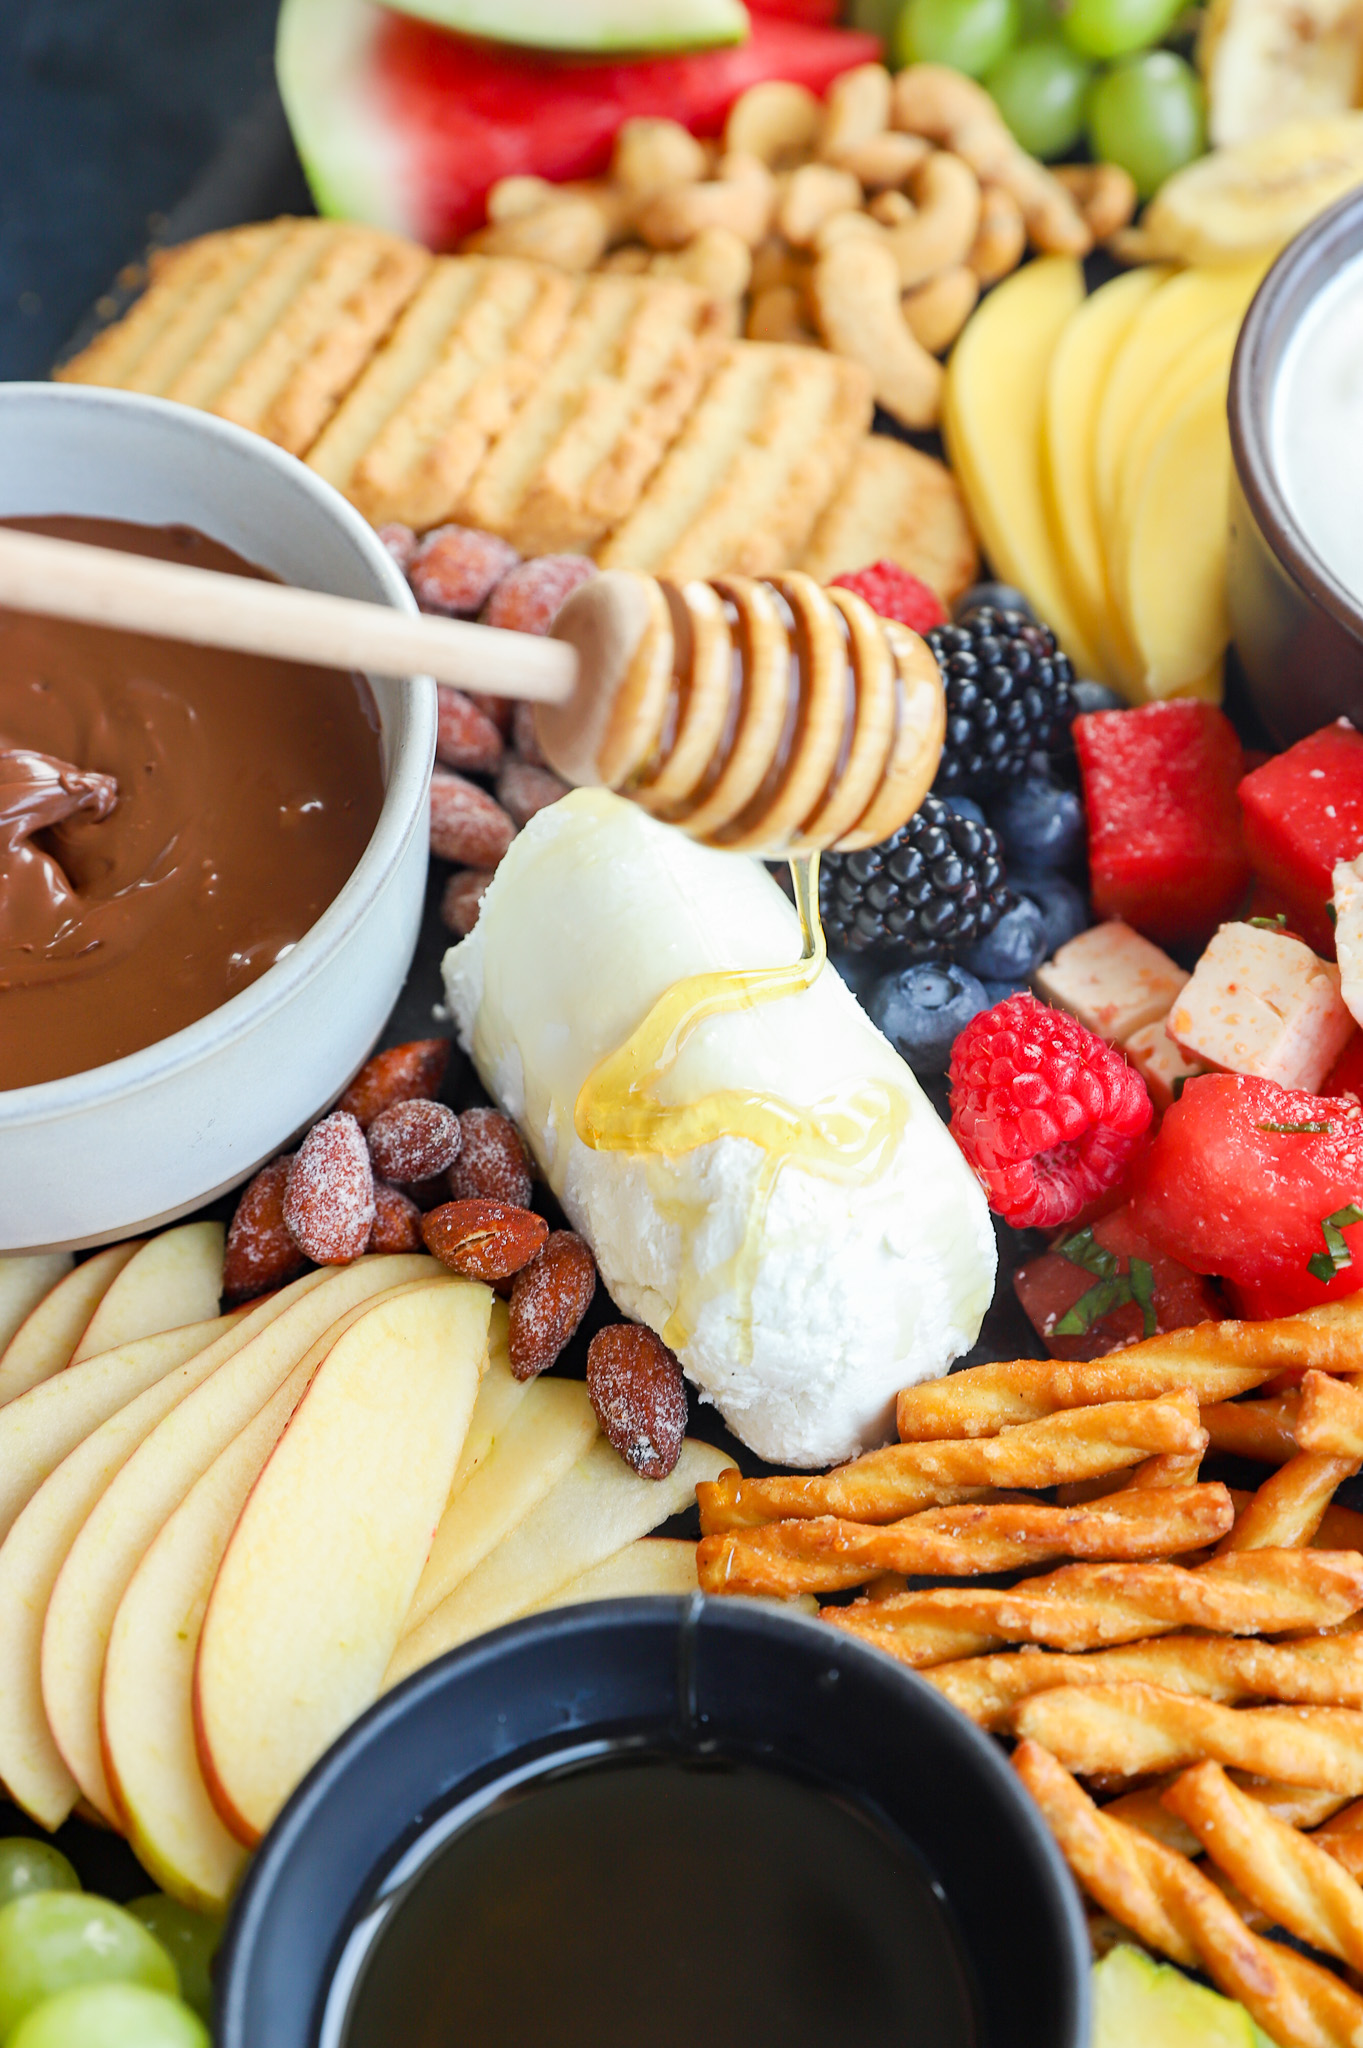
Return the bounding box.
[1271,256,1363,600]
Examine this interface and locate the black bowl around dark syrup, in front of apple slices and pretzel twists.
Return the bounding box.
[213,1595,1089,2048]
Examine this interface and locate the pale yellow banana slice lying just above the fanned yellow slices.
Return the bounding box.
[1142,113,1363,264]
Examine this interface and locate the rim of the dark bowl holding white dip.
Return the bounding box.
[1226,188,1363,641]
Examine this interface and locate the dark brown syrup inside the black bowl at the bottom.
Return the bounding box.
[333,1751,980,2048]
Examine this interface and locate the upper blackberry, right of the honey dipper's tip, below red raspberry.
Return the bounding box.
[927,604,1074,795]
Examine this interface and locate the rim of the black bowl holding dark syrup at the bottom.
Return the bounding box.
[215,1591,1093,2048]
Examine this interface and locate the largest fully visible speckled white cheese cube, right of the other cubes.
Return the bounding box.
[1169,924,1355,1094]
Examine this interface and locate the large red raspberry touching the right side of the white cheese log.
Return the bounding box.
[952,995,1152,1231]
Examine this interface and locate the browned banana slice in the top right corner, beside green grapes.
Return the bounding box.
[1197,0,1363,147]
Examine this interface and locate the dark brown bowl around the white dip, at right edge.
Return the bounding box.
[1228,190,1363,745]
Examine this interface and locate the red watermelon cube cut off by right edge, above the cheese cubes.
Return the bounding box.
[1240,719,1363,956]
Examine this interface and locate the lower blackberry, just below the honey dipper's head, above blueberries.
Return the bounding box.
[819,797,1011,961]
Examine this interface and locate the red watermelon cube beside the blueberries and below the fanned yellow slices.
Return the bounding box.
[1074,702,1248,946]
